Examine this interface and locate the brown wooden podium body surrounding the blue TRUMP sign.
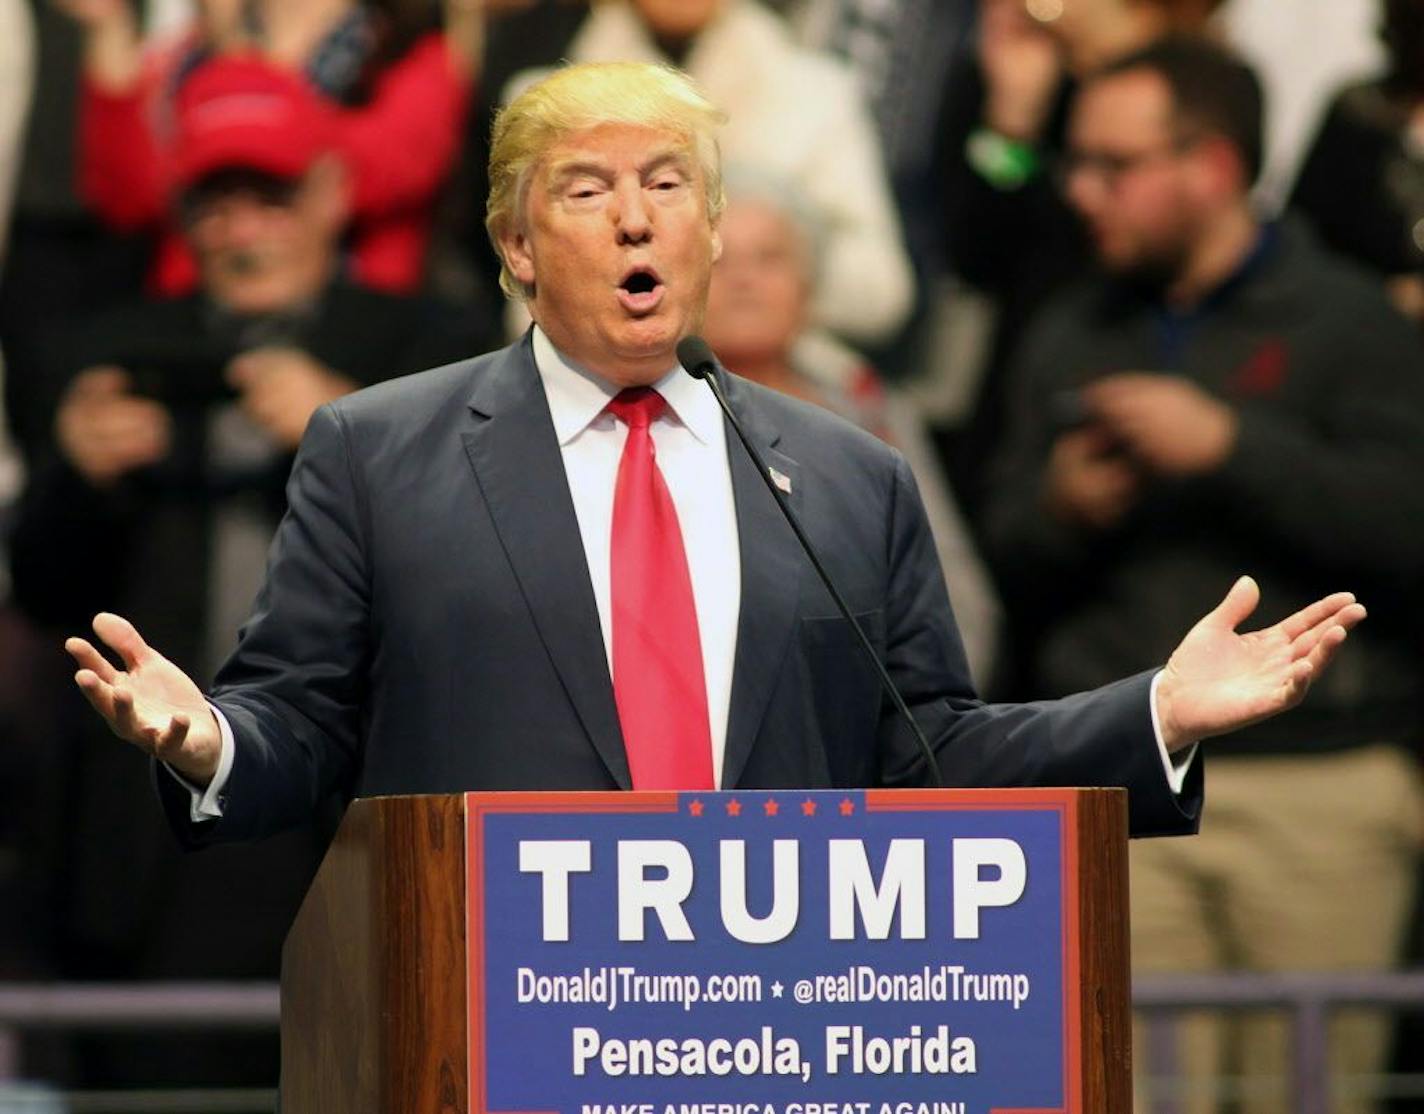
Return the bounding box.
[281,789,1132,1114]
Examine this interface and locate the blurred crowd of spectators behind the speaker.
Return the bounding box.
[0,0,1424,1114]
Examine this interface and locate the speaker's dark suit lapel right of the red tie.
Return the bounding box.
[719,370,805,789]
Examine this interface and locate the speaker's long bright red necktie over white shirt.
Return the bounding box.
[608,387,716,789]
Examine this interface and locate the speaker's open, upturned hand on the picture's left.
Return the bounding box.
[64,613,222,786]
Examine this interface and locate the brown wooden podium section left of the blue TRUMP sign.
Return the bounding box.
[281,793,468,1114]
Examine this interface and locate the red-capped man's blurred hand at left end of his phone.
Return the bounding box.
[54,368,172,487]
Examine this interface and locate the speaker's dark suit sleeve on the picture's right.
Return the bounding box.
[880,460,1202,835]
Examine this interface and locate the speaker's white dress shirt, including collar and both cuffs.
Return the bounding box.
[174,325,1196,822]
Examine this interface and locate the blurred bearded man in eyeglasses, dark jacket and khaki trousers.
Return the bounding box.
[985,40,1424,1114]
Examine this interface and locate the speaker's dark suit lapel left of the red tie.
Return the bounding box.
[464,335,632,789]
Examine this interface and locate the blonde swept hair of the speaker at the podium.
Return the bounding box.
[484,61,726,298]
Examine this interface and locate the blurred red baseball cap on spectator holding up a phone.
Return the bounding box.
[174,56,333,189]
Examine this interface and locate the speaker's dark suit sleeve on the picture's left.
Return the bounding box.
[158,406,370,845]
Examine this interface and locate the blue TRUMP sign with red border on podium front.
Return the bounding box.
[466,789,1085,1114]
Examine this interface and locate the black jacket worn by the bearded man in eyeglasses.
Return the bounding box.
[985,225,1424,751]
